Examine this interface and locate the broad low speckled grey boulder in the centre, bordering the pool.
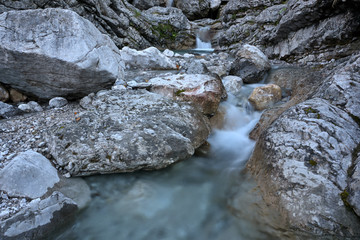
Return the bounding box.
[46,90,210,176]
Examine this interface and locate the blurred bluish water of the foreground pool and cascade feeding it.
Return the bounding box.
[55,86,310,240]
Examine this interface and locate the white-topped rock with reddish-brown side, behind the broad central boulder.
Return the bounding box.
[149,74,227,115]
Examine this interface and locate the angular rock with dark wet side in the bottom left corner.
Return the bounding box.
[0,192,78,240]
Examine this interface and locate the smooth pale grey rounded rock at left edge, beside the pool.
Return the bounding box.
[0,150,60,199]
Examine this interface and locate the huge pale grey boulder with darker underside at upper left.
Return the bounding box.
[0,9,123,99]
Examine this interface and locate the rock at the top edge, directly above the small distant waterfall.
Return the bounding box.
[174,0,211,20]
